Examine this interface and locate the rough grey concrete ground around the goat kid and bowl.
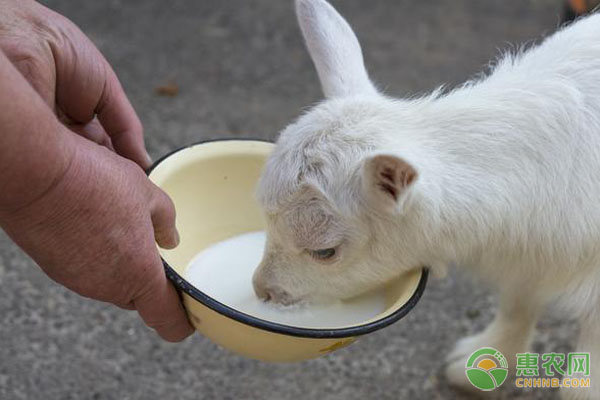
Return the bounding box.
[0,0,575,400]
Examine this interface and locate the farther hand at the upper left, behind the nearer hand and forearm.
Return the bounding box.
[0,0,151,168]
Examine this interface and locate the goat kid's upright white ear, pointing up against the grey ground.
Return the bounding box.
[296,0,377,98]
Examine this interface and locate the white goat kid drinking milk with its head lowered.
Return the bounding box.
[254,0,600,398]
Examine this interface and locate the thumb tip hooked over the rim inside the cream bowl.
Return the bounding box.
[151,185,179,249]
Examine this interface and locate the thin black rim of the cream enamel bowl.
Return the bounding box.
[146,138,429,339]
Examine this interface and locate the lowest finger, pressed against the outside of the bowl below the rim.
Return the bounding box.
[133,259,194,342]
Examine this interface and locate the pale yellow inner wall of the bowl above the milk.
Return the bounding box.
[150,140,422,329]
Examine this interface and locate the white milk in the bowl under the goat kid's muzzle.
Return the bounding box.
[185,232,385,328]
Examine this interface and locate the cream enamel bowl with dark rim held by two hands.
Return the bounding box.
[149,140,427,362]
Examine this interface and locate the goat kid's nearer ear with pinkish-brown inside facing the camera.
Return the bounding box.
[362,154,418,211]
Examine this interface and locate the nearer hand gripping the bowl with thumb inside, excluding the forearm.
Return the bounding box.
[0,130,193,341]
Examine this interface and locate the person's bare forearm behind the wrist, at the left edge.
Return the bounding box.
[0,51,73,216]
